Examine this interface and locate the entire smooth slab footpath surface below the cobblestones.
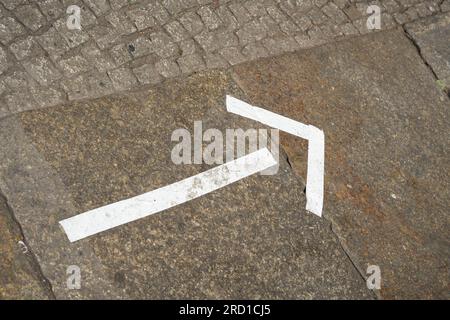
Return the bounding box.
[0,5,450,299]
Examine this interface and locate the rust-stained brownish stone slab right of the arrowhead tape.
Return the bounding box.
[235,30,450,299]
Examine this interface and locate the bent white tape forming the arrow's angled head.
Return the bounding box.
[226,95,325,217]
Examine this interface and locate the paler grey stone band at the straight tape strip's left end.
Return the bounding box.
[0,117,125,298]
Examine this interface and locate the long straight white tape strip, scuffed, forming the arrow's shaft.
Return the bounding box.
[59,148,277,242]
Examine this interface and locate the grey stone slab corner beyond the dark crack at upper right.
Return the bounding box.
[405,13,450,89]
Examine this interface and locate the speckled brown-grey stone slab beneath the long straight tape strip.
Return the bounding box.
[0,72,374,299]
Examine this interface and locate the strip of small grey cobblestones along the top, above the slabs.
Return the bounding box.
[0,0,450,117]
